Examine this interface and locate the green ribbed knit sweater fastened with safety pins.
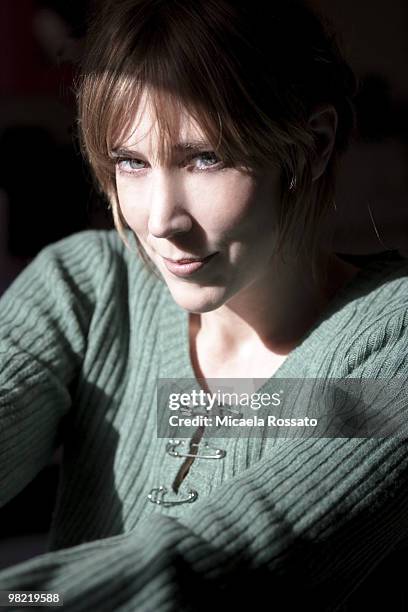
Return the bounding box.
[0,231,408,612]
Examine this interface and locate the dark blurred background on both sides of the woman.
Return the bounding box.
[0,0,408,580]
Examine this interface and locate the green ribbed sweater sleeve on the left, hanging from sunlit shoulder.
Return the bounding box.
[0,232,101,506]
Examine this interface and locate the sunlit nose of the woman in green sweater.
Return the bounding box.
[148,170,192,238]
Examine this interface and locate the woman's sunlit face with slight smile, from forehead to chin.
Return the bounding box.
[114,93,286,313]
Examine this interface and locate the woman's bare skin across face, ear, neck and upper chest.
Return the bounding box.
[116,90,358,377]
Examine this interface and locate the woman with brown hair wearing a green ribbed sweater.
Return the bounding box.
[0,0,408,611]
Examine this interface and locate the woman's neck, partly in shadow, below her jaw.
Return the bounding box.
[190,254,358,355]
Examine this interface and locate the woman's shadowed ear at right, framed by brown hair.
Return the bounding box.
[309,106,338,181]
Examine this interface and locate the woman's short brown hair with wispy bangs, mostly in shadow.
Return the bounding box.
[78,0,356,280]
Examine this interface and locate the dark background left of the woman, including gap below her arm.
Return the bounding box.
[0,0,113,569]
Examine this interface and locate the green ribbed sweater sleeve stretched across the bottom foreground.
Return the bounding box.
[0,304,408,612]
